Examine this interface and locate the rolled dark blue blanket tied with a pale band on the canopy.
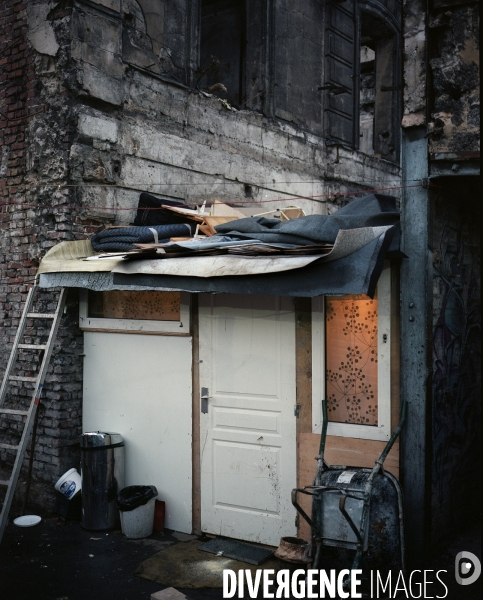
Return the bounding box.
[91,223,196,252]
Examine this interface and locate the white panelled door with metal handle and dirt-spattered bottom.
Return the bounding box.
[200,294,296,545]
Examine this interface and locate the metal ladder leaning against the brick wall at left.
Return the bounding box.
[0,285,67,542]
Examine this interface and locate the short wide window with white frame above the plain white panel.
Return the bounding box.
[79,290,190,335]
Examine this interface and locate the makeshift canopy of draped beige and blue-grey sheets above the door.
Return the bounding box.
[39,194,399,297]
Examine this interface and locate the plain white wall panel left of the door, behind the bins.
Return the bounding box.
[83,332,192,533]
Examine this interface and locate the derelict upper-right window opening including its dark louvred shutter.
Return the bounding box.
[326,0,401,162]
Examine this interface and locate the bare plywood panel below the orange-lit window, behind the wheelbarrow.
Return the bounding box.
[298,433,399,540]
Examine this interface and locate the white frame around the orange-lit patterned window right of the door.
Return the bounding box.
[312,266,391,441]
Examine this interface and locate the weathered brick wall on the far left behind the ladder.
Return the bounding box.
[0,0,98,507]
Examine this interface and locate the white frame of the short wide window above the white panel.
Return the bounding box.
[79,289,191,336]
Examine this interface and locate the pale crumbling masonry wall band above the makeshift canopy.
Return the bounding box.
[70,0,400,223]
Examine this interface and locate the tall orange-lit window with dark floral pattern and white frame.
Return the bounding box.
[312,268,391,440]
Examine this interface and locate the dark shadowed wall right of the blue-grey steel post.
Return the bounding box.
[431,177,481,545]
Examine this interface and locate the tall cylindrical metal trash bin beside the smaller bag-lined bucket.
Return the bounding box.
[81,431,124,531]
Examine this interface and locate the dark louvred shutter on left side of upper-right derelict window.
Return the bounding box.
[322,0,356,147]
